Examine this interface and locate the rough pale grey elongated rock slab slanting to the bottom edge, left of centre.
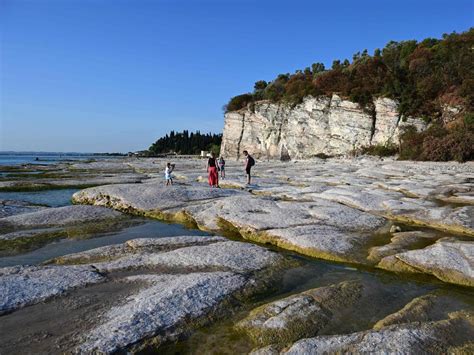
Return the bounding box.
[78,272,247,353]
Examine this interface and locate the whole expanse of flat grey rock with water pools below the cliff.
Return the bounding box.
[0,158,474,354]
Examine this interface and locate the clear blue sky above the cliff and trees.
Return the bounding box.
[0,0,474,152]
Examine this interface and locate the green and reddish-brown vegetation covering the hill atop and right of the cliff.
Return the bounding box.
[224,28,474,161]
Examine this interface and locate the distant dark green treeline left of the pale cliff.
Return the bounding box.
[148,130,222,154]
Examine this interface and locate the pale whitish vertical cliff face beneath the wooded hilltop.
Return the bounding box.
[221,95,426,160]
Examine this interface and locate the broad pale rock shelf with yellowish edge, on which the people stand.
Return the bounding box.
[73,158,474,285]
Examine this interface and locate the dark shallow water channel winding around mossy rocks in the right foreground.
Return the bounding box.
[154,251,474,354]
